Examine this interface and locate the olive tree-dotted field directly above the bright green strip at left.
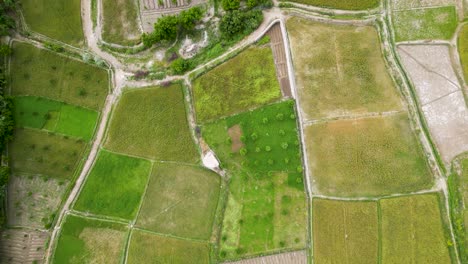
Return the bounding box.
[11,43,109,111]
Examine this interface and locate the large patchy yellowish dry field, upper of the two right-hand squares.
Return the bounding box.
[287,18,402,120]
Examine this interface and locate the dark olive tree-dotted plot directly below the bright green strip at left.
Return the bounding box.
[8,128,86,179]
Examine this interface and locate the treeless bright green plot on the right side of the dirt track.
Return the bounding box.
[74,150,151,220]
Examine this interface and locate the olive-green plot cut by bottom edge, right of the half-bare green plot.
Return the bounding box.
[127,230,210,264]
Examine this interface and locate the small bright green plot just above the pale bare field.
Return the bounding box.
[392,6,458,42]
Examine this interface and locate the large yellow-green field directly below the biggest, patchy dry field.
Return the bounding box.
[305,113,432,196]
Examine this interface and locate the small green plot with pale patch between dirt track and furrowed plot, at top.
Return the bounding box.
[102,0,141,45]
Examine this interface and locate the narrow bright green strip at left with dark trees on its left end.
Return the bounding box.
[14,96,98,140]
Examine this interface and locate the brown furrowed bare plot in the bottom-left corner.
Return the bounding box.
[0,229,49,264]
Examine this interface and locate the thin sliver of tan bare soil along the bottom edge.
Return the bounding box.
[225,250,307,264]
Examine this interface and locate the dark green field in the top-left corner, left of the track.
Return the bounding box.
[21,0,84,46]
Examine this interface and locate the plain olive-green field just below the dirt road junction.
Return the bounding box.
[105,84,199,163]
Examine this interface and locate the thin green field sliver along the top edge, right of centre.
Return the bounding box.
[282,0,380,10]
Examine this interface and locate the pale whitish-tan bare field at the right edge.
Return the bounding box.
[398,45,468,163]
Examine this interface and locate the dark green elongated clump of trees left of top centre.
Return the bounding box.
[142,7,204,47]
